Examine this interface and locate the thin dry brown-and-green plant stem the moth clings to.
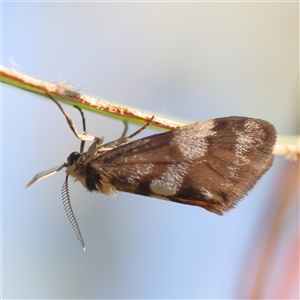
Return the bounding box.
[0,66,300,160]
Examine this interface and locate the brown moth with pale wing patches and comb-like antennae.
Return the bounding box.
[27,97,276,250]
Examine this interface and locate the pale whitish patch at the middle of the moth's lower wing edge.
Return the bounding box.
[150,163,188,197]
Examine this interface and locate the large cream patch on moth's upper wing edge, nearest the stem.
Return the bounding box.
[174,120,217,160]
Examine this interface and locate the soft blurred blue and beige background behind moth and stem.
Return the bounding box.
[1,2,299,299]
